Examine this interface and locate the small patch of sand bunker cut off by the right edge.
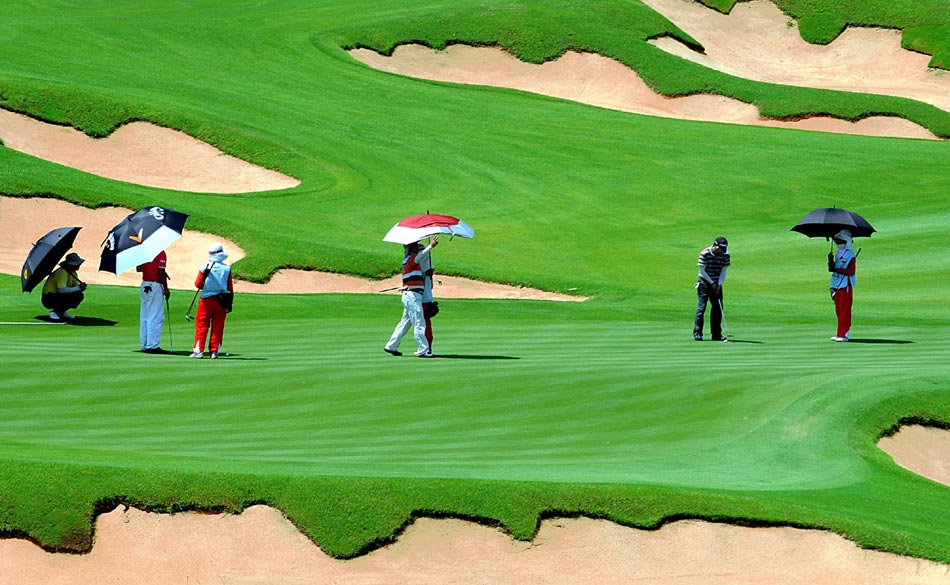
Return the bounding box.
[877,425,950,485]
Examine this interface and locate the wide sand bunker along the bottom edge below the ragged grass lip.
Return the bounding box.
[0,506,950,585]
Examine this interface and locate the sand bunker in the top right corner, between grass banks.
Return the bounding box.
[644,0,950,111]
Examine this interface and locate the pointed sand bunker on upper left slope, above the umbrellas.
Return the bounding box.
[0,109,300,193]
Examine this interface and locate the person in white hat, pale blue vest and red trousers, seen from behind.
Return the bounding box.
[191,242,234,359]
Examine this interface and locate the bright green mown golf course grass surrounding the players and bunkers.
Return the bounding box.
[0,0,950,562]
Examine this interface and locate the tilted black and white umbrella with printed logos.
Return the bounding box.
[99,206,188,275]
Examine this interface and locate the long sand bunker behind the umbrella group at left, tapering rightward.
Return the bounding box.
[0,197,586,305]
